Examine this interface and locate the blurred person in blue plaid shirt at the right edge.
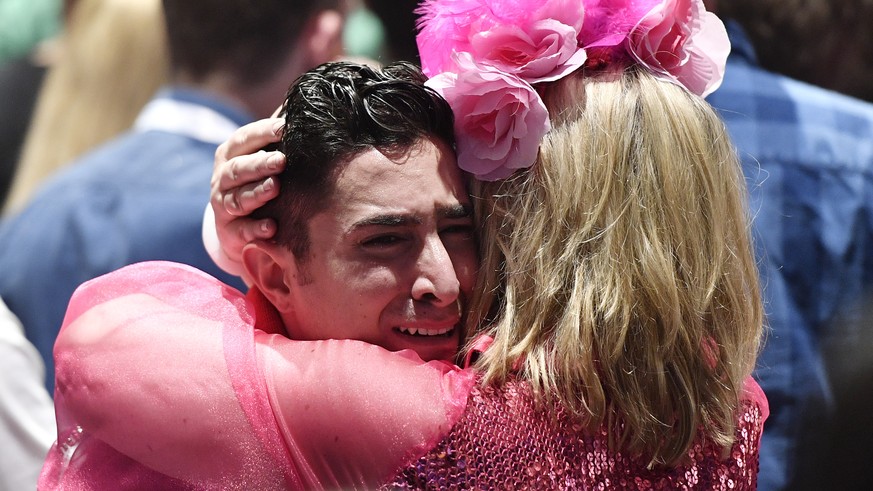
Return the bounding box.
[707,0,873,491]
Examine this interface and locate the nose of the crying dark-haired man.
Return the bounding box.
[412,236,461,307]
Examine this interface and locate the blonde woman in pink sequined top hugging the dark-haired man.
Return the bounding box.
[51,1,767,489]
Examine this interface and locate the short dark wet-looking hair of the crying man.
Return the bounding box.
[256,62,454,261]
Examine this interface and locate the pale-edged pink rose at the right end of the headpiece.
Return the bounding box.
[629,0,730,97]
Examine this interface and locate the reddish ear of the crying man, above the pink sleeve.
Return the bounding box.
[242,240,297,312]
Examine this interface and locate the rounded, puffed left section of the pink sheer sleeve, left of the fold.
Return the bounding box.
[47,263,284,489]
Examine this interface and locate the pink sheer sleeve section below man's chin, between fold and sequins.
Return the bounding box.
[257,333,474,489]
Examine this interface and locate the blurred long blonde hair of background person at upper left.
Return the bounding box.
[4,0,169,213]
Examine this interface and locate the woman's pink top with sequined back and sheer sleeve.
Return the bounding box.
[39,263,767,490]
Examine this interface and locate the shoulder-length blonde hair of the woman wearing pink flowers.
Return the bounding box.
[470,67,762,465]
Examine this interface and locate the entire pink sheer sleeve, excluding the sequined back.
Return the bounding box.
[40,263,473,489]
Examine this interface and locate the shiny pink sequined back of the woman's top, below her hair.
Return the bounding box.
[382,380,764,491]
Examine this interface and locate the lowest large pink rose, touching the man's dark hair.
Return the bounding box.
[425,53,550,181]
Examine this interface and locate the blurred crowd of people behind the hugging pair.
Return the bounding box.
[0,0,873,491]
